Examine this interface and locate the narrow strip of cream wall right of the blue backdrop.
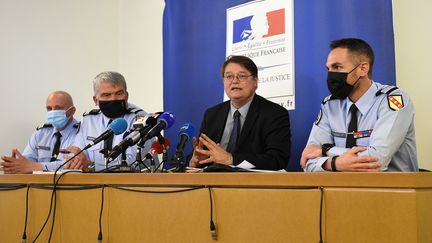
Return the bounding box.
[393,0,432,170]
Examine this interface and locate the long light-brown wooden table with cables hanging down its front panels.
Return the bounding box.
[0,173,432,243]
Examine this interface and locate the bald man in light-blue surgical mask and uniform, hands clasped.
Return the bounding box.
[0,91,79,174]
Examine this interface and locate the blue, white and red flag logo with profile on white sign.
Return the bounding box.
[233,8,285,44]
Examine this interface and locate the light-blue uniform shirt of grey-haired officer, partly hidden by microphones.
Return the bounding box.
[75,103,153,171]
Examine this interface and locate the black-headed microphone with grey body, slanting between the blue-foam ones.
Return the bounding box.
[108,116,157,162]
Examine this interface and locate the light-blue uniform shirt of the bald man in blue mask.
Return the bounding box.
[22,119,79,170]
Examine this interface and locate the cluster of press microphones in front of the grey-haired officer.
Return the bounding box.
[83,112,195,171]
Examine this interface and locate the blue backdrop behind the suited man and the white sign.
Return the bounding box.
[163,0,396,171]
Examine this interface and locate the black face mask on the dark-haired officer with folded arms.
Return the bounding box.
[327,64,360,99]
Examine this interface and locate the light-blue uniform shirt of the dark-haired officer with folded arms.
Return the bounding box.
[305,82,418,171]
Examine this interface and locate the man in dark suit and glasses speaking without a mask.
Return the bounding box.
[191,56,291,170]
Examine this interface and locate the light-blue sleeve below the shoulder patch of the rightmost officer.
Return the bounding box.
[358,94,414,170]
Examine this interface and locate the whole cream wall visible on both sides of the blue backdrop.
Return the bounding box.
[0,0,432,169]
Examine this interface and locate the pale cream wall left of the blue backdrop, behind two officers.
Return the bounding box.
[0,0,164,155]
